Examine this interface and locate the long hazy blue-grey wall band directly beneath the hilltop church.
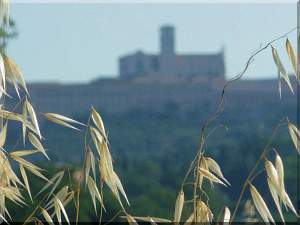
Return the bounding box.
[18,77,290,116]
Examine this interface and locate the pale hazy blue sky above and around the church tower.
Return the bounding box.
[8,3,297,82]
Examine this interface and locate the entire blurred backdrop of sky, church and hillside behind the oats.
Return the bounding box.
[0,1,299,220]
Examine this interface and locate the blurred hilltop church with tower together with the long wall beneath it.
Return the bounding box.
[9,27,296,119]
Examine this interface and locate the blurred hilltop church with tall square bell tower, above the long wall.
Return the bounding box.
[119,26,225,79]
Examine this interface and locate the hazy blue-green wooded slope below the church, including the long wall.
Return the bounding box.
[2,77,297,220]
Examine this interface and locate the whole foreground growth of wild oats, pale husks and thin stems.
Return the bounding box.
[0,0,300,224]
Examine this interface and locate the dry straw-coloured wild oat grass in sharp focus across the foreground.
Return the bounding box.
[0,0,300,224]
